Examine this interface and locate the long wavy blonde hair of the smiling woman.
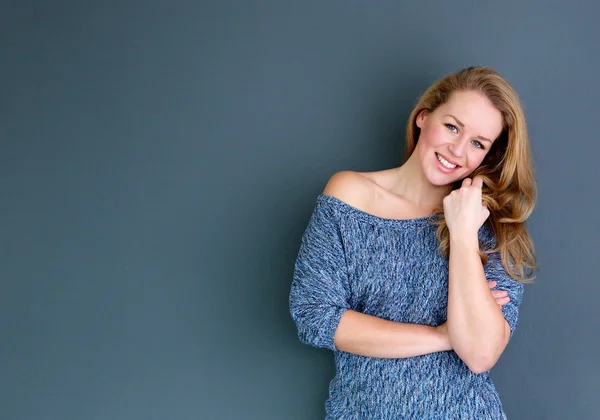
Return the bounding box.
[405,67,537,283]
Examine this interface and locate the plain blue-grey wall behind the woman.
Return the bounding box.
[0,0,600,420]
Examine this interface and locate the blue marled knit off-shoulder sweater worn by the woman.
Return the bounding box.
[289,194,523,420]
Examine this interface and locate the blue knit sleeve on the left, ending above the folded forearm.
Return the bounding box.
[289,200,350,350]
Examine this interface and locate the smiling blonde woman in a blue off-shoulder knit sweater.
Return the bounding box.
[290,67,537,419]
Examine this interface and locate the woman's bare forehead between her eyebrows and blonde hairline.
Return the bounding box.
[436,91,502,140]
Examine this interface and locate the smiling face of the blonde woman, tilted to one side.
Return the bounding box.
[415,91,502,186]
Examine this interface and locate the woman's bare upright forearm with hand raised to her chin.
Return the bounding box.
[444,177,519,373]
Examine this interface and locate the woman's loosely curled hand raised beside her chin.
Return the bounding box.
[443,176,490,238]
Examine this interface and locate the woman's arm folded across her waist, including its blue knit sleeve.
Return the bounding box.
[289,194,450,358]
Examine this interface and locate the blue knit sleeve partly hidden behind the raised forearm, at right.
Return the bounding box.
[484,248,523,338]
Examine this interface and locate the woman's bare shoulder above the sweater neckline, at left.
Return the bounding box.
[323,171,373,208]
